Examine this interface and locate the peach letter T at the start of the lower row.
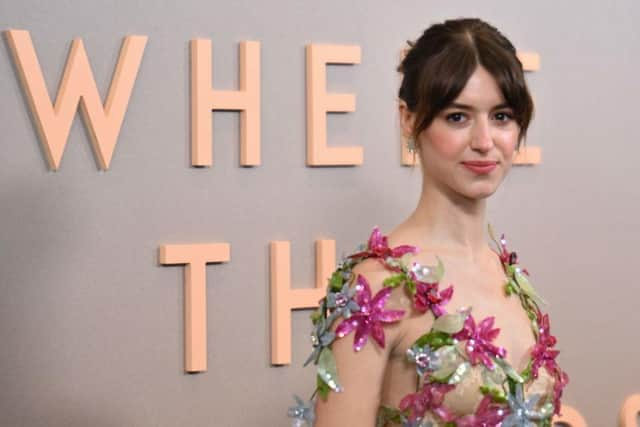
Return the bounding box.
[160,243,230,372]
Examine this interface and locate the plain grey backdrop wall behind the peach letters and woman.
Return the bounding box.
[0,0,640,426]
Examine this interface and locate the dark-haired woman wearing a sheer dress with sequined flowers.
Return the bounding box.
[290,19,568,427]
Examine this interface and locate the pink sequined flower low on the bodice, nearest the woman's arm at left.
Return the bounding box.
[399,383,455,422]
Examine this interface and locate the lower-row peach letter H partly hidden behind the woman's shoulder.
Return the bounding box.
[270,240,336,365]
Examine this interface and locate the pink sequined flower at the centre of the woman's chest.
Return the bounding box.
[453,315,507,370]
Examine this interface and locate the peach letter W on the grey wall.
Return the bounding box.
[6,30,147,170]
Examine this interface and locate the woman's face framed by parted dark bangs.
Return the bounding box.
[401,66,520,199]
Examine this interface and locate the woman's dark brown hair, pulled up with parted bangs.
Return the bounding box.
[398,18,534,148]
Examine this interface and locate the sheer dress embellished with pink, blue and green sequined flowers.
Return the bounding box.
[289,225,569,427]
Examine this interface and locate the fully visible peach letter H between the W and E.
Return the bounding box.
[191,39,260,166]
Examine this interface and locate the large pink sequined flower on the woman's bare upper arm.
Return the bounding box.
[336,274,404,351]
